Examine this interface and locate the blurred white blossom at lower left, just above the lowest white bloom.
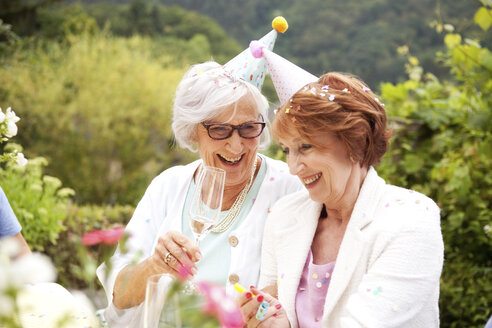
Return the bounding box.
[11,253,56,286]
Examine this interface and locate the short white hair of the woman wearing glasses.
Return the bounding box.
[172,61,270,152]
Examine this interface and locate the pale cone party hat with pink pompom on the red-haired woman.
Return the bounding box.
[249,41,318,104]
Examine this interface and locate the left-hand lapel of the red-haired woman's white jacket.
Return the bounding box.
[276,193,322,322]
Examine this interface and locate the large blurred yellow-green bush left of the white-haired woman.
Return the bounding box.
[0,34,200,204]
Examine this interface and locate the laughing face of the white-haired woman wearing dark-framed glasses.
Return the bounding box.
[196,97,260,187]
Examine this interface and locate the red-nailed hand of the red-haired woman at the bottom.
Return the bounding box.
[236,286,290,328]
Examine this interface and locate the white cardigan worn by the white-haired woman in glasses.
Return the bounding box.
[97,155,303,328]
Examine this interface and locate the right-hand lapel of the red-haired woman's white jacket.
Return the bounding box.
[323,167,385,320]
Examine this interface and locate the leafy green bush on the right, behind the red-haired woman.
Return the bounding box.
[378,6,492,328]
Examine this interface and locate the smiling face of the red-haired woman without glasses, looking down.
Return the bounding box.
[279,133,361,208]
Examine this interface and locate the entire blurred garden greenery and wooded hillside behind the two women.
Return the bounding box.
[0,0,492,327]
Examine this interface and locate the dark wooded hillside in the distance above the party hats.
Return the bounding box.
[160,0,492,85]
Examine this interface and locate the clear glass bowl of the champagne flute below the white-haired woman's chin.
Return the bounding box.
[189,166,225,246]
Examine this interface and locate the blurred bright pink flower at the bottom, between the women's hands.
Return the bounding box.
[197,281,244,328]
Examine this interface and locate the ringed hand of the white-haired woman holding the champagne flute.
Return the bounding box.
[150,231,201,278]
